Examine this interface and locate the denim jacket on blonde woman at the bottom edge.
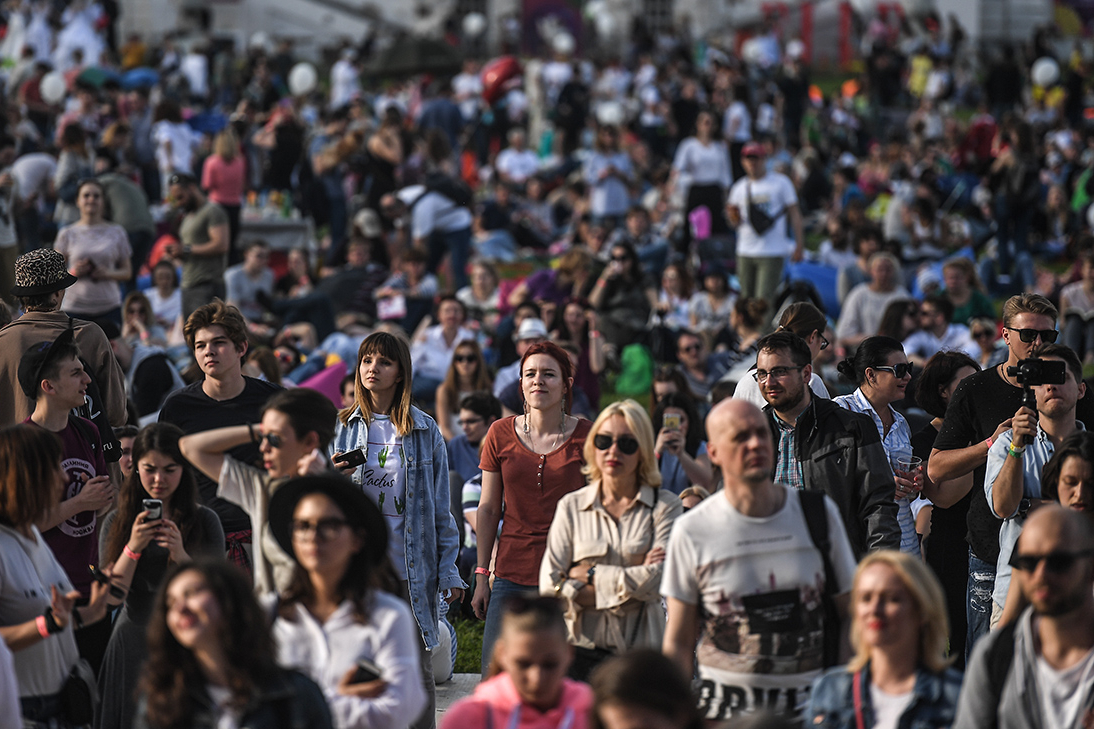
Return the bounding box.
[804,663,962,729]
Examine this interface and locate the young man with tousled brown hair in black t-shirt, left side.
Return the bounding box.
[160,299,281,571]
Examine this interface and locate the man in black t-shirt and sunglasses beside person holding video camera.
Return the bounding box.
[928,293,1094,657]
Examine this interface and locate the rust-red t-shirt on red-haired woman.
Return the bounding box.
[479,416,592,586]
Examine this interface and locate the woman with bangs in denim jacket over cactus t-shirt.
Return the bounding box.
[329,332,467,728]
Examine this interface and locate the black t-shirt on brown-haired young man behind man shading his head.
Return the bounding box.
[160,378,281,527]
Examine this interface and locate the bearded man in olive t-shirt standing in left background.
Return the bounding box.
[161,172,231,321]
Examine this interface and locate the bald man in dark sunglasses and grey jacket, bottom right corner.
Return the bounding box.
[954,504,1094,729]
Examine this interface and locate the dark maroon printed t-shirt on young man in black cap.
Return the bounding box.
[24,418,109,598]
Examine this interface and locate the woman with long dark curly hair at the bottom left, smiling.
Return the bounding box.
[134,559,333,729]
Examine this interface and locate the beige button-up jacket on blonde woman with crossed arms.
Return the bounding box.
[539,482,684,652]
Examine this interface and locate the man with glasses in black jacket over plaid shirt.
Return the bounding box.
[754,332,900,558]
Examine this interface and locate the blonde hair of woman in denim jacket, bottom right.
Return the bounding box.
[847,549,952,673]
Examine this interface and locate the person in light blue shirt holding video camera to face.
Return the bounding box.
[984,344,1086,628]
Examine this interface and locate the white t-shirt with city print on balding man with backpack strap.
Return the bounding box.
[661,486,854,720]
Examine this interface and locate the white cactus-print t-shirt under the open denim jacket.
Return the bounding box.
[361,413,407,580]
